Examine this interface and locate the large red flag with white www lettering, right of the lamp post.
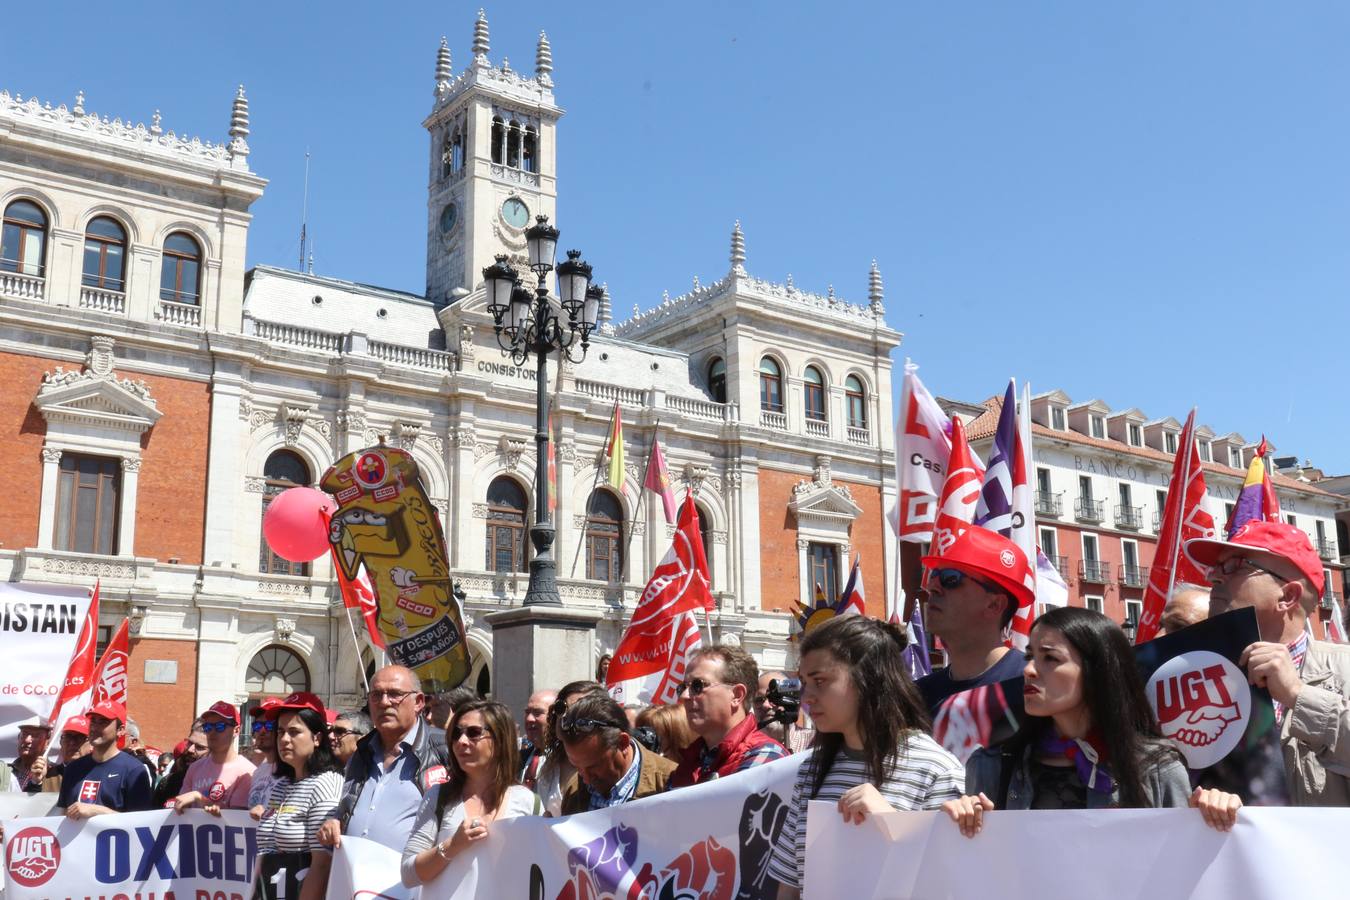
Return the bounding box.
[605,491,713,704]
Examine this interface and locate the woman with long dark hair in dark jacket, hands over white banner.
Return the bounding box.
[942,606,1237,837]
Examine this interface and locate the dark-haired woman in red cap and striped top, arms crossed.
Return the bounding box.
[252,692,342,900]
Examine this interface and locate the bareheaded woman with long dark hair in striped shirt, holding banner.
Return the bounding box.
[768,615,965,900]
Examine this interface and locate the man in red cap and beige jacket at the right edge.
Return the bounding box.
[1185,519,1350,806]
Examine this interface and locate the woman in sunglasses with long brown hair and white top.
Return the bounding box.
[402,700,544,888]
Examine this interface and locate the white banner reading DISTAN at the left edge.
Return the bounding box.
[0,582,89,760]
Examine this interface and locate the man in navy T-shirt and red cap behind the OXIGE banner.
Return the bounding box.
[57,702,151,819]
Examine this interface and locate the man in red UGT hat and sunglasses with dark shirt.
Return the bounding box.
[917,525,1035,715]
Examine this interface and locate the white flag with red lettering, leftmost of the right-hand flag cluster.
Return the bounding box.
[891,363,952,542]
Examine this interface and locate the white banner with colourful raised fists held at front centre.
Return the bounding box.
[328,754,806,900]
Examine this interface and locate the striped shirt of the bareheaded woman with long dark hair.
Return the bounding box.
[768,731,965,888]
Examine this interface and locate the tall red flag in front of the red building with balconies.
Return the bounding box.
[1134,409,1214,644]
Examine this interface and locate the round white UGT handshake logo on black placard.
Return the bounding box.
[1148,650,1251,769]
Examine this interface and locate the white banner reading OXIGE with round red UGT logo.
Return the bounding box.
[4,810,258,900]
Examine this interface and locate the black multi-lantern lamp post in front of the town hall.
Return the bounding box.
[483,216,601,606]
